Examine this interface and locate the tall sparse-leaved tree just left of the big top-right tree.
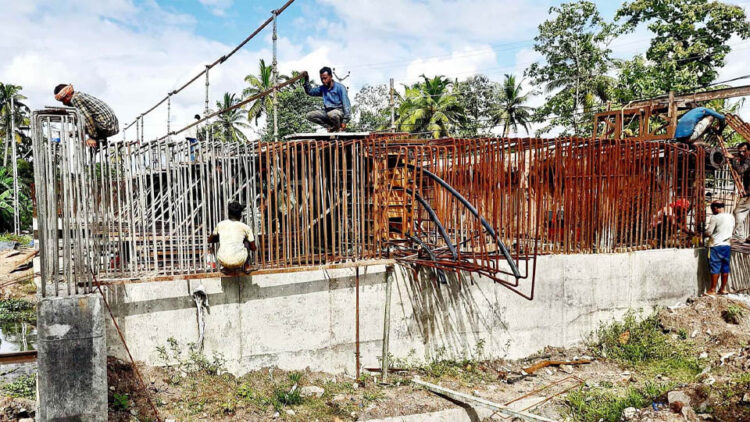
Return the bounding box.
[526,1,617,135]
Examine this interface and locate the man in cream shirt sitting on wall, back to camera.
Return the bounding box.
[208,202,258,273]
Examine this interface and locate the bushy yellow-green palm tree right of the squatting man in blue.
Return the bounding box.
[396,75,461,138]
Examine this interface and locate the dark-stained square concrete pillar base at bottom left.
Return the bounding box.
[37,294,107,422]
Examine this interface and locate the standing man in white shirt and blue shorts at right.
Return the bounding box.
[706,202,734,296]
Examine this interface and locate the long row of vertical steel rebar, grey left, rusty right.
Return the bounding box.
[33,108,705,299]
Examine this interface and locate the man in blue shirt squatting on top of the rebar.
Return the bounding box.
[304,66,352,132]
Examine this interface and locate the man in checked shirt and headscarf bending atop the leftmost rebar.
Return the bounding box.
[55,84,120,148]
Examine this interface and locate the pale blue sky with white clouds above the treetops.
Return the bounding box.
[0,0,750,137]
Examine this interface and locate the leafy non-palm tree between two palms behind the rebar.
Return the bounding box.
[454,75,500,136]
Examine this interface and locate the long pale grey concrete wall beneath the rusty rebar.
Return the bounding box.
[107,249,705,374]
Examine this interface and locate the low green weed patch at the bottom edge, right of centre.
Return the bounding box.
[565,383,673,422]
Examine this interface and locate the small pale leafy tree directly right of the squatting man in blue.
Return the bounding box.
[349,84,398,132]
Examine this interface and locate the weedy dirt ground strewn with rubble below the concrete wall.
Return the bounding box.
[0,286,750,422]
